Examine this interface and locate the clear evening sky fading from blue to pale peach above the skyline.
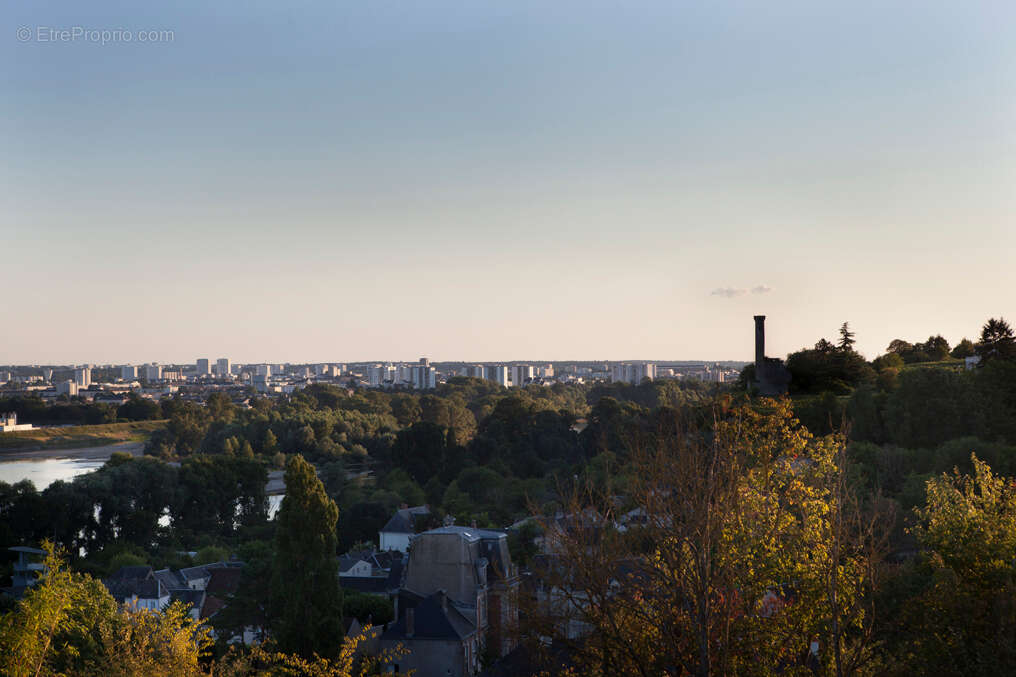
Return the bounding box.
[0,0,1016,364]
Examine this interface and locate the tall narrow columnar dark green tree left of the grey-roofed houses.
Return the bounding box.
[271,454,342,658]
